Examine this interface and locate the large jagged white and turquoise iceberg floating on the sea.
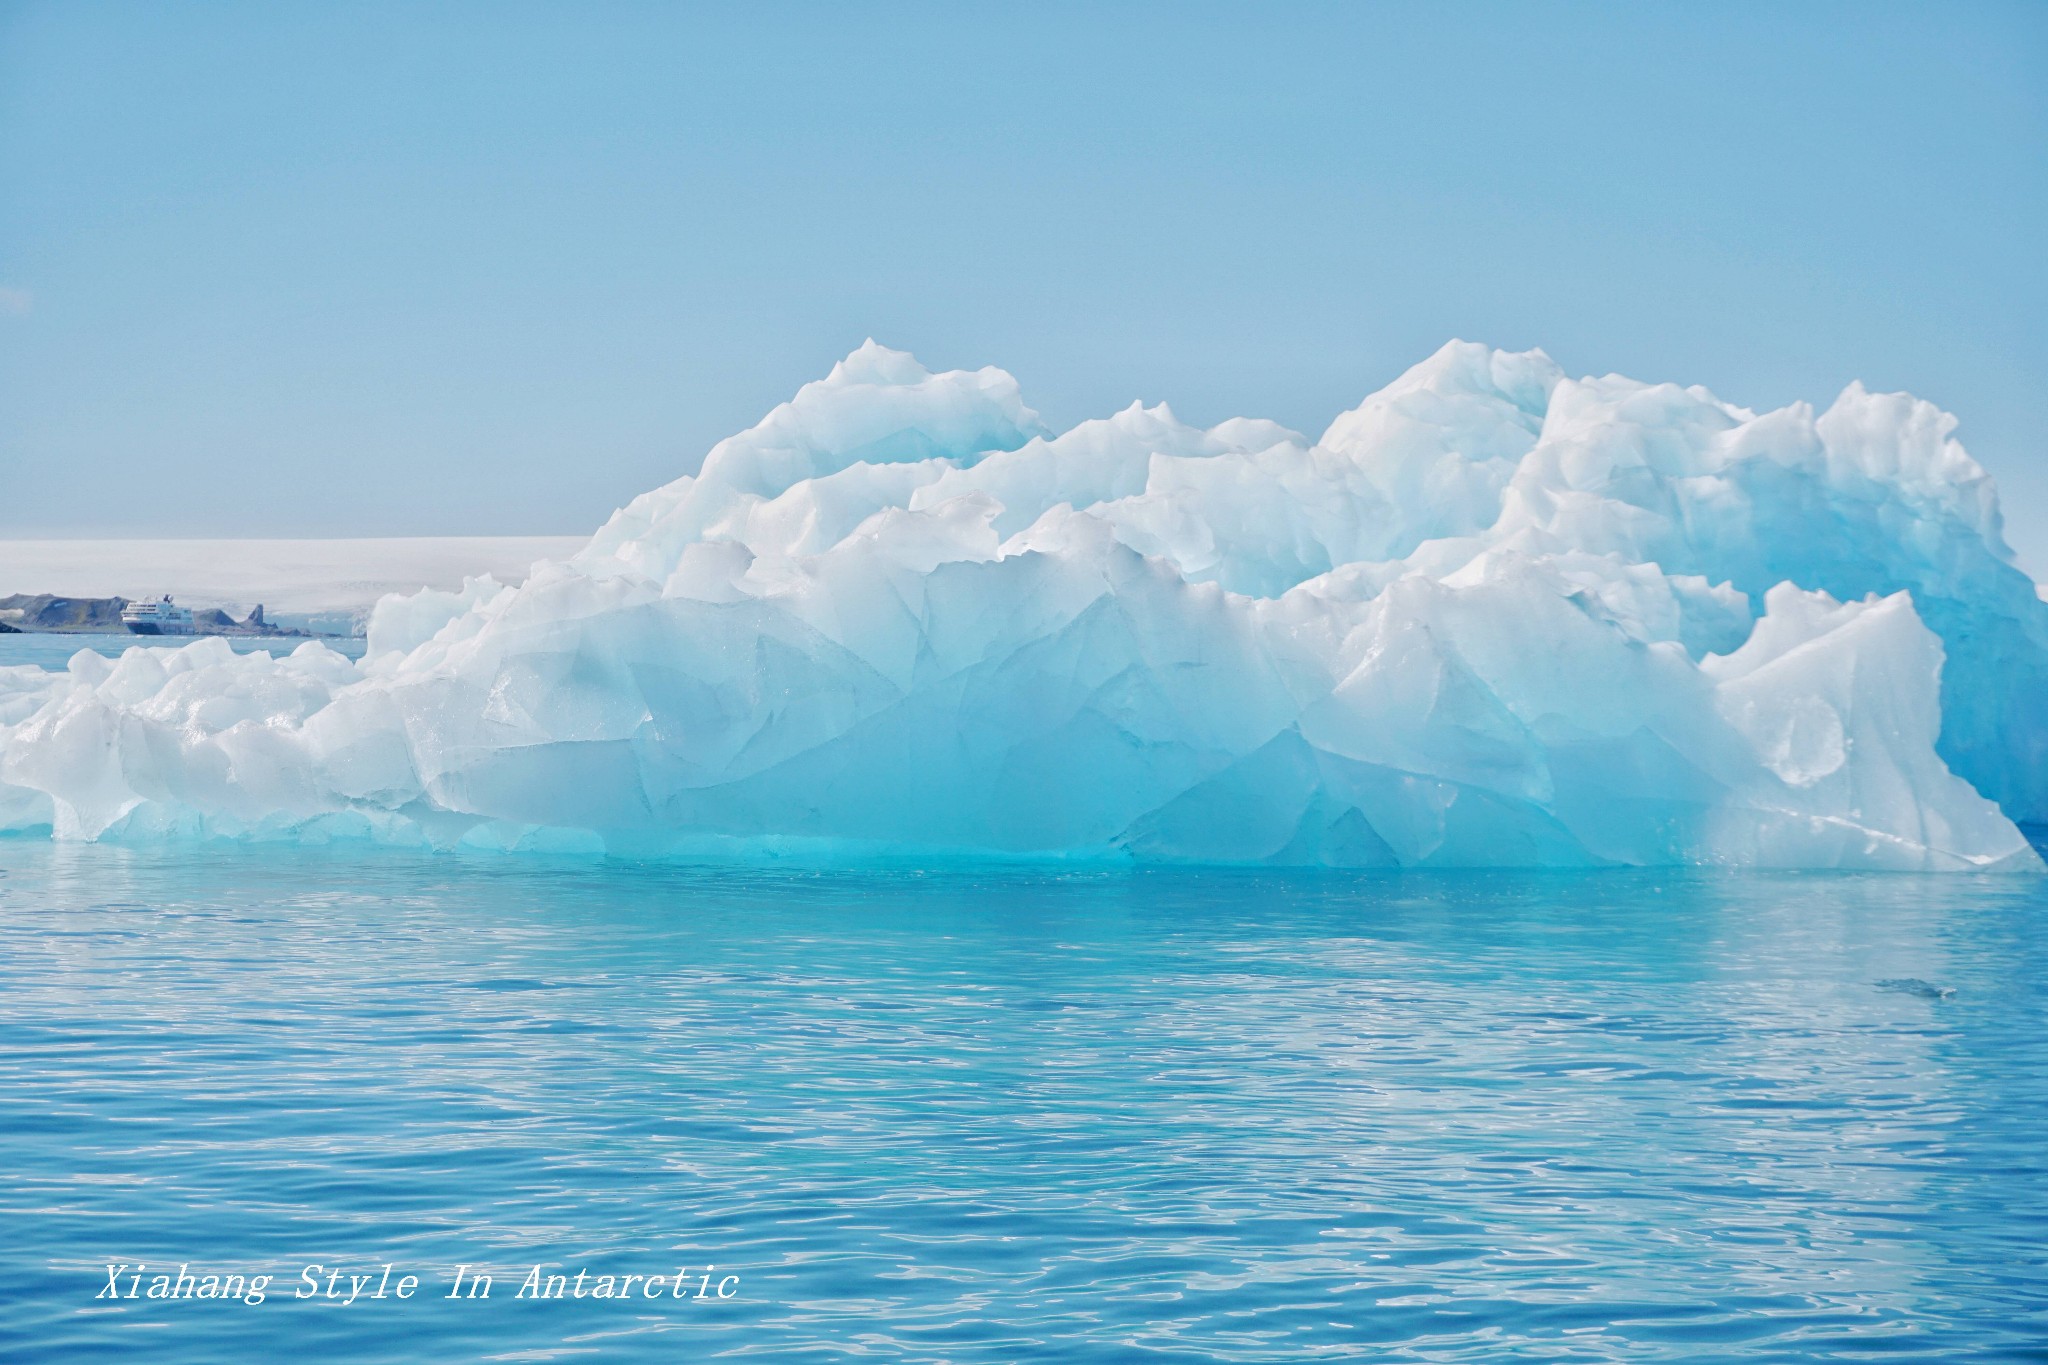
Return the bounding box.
[0,342,2048,868]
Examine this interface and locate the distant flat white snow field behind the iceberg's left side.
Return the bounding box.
[0,536,588,620]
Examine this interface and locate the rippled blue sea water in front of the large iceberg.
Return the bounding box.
[0,839,2048,1361]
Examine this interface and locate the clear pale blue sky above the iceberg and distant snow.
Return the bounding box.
[0,2,2048,571]
